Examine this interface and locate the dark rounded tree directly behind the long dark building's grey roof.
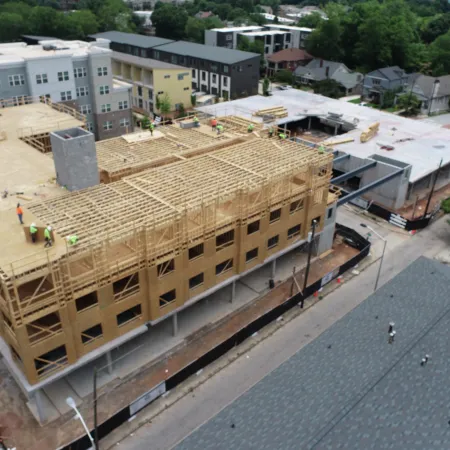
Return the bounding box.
[152,3,188,40]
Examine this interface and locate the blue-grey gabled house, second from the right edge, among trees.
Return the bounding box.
[362,66,409,104]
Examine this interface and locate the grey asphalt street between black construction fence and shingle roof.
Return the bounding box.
[107,210,450,450]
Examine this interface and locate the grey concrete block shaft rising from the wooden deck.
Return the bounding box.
[50,128,100,191]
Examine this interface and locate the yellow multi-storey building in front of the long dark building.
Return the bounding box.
[112,52,192,115]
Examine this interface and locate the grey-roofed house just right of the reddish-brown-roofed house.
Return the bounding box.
[294,59,364,95]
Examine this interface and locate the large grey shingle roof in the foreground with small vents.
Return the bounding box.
[176,257,450,450]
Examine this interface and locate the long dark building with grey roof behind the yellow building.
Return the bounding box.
[91,31,260,98]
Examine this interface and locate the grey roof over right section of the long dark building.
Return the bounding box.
[151,41,259,64]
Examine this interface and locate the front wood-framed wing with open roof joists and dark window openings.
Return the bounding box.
[0,132,333,383]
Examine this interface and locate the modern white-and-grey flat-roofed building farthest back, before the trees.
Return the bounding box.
[205,24,313,55]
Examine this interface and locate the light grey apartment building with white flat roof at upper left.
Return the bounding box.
[0,40,133,140]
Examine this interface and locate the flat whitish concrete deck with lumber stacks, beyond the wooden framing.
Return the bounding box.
[197,89,450,183]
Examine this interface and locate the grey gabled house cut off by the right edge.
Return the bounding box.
[405,74,450,114]
